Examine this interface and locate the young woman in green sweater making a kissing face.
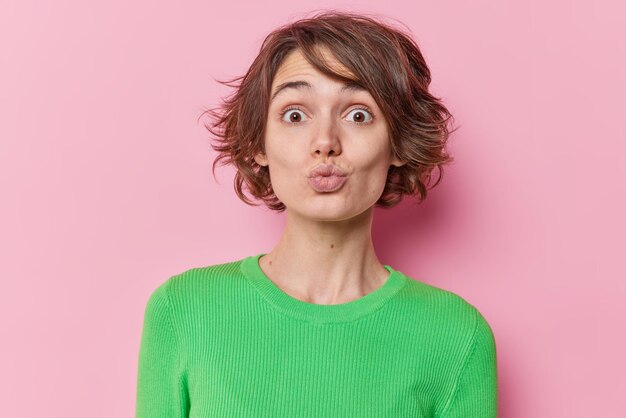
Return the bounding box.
[136,11,497,418]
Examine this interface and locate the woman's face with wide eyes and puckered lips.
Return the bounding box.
[255,50,402,221]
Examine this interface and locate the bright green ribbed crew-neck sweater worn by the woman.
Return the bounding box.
[136,253,497,418]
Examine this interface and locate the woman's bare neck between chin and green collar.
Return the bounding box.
[259,209,389,305]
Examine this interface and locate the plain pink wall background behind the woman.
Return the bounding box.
[0,0,626,418]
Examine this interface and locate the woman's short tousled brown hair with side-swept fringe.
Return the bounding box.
[201,10,456,212]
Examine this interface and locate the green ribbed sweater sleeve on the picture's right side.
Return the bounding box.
[440,311,498,418]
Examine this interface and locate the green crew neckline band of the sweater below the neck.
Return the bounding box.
[241,253,406,323]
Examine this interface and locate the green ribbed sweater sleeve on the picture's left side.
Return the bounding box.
[135,279,190,418]
